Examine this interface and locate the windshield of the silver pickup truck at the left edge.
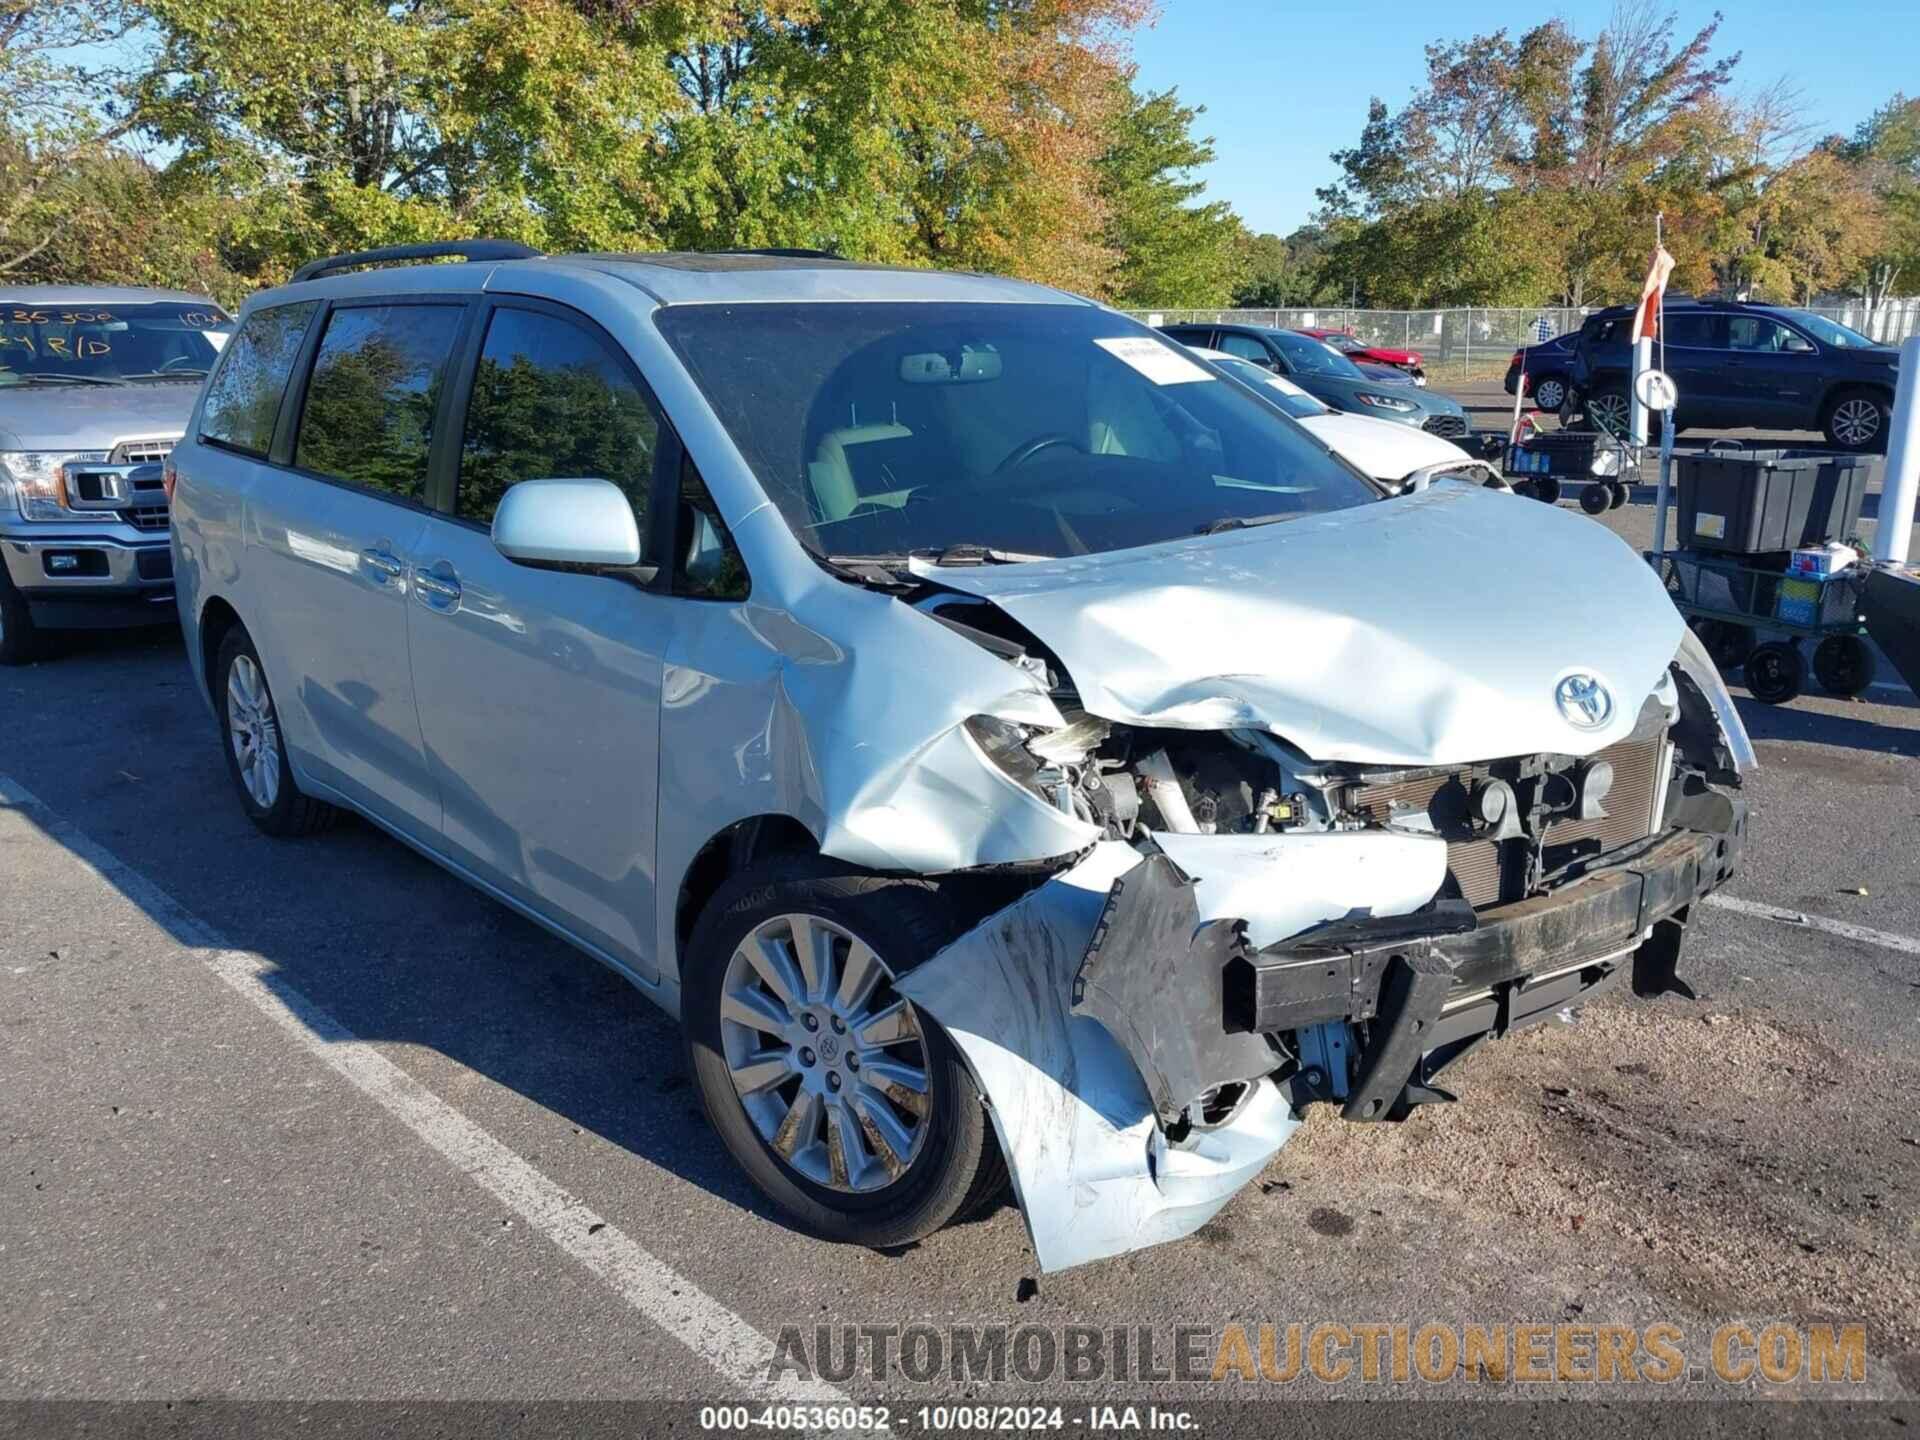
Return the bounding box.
[0,301,234,386]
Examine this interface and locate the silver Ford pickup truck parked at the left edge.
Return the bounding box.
[0,286,232,664]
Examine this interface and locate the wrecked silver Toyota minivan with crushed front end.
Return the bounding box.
[169,242,1751,1269]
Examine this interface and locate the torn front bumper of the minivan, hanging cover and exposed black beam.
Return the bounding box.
[899,814,1745,1271]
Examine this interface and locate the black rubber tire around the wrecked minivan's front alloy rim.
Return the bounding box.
[682,856,1008,1250]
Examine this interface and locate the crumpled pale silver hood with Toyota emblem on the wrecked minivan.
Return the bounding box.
[916,482,1684,764]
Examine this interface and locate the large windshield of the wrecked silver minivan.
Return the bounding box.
[655,303,1380,557]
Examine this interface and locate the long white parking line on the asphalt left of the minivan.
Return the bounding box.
[0,776,847,1404]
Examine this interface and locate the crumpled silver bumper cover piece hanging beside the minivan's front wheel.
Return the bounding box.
[897,841,1298,1271]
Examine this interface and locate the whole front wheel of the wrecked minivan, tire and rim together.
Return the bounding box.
[682,860,1006,1248]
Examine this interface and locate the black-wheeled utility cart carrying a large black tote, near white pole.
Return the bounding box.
[1647,442,1876,705]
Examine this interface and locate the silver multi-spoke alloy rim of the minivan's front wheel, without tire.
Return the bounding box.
[720,914,931,1194]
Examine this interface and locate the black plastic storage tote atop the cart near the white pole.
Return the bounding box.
[1674,449,1872,555]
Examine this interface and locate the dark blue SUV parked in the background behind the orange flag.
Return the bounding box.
[1571,300,1899,451]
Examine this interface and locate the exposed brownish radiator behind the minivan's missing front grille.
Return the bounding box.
[1348,724,1667,910]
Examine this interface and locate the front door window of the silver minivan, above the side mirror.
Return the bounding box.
[453,309,660,536]
